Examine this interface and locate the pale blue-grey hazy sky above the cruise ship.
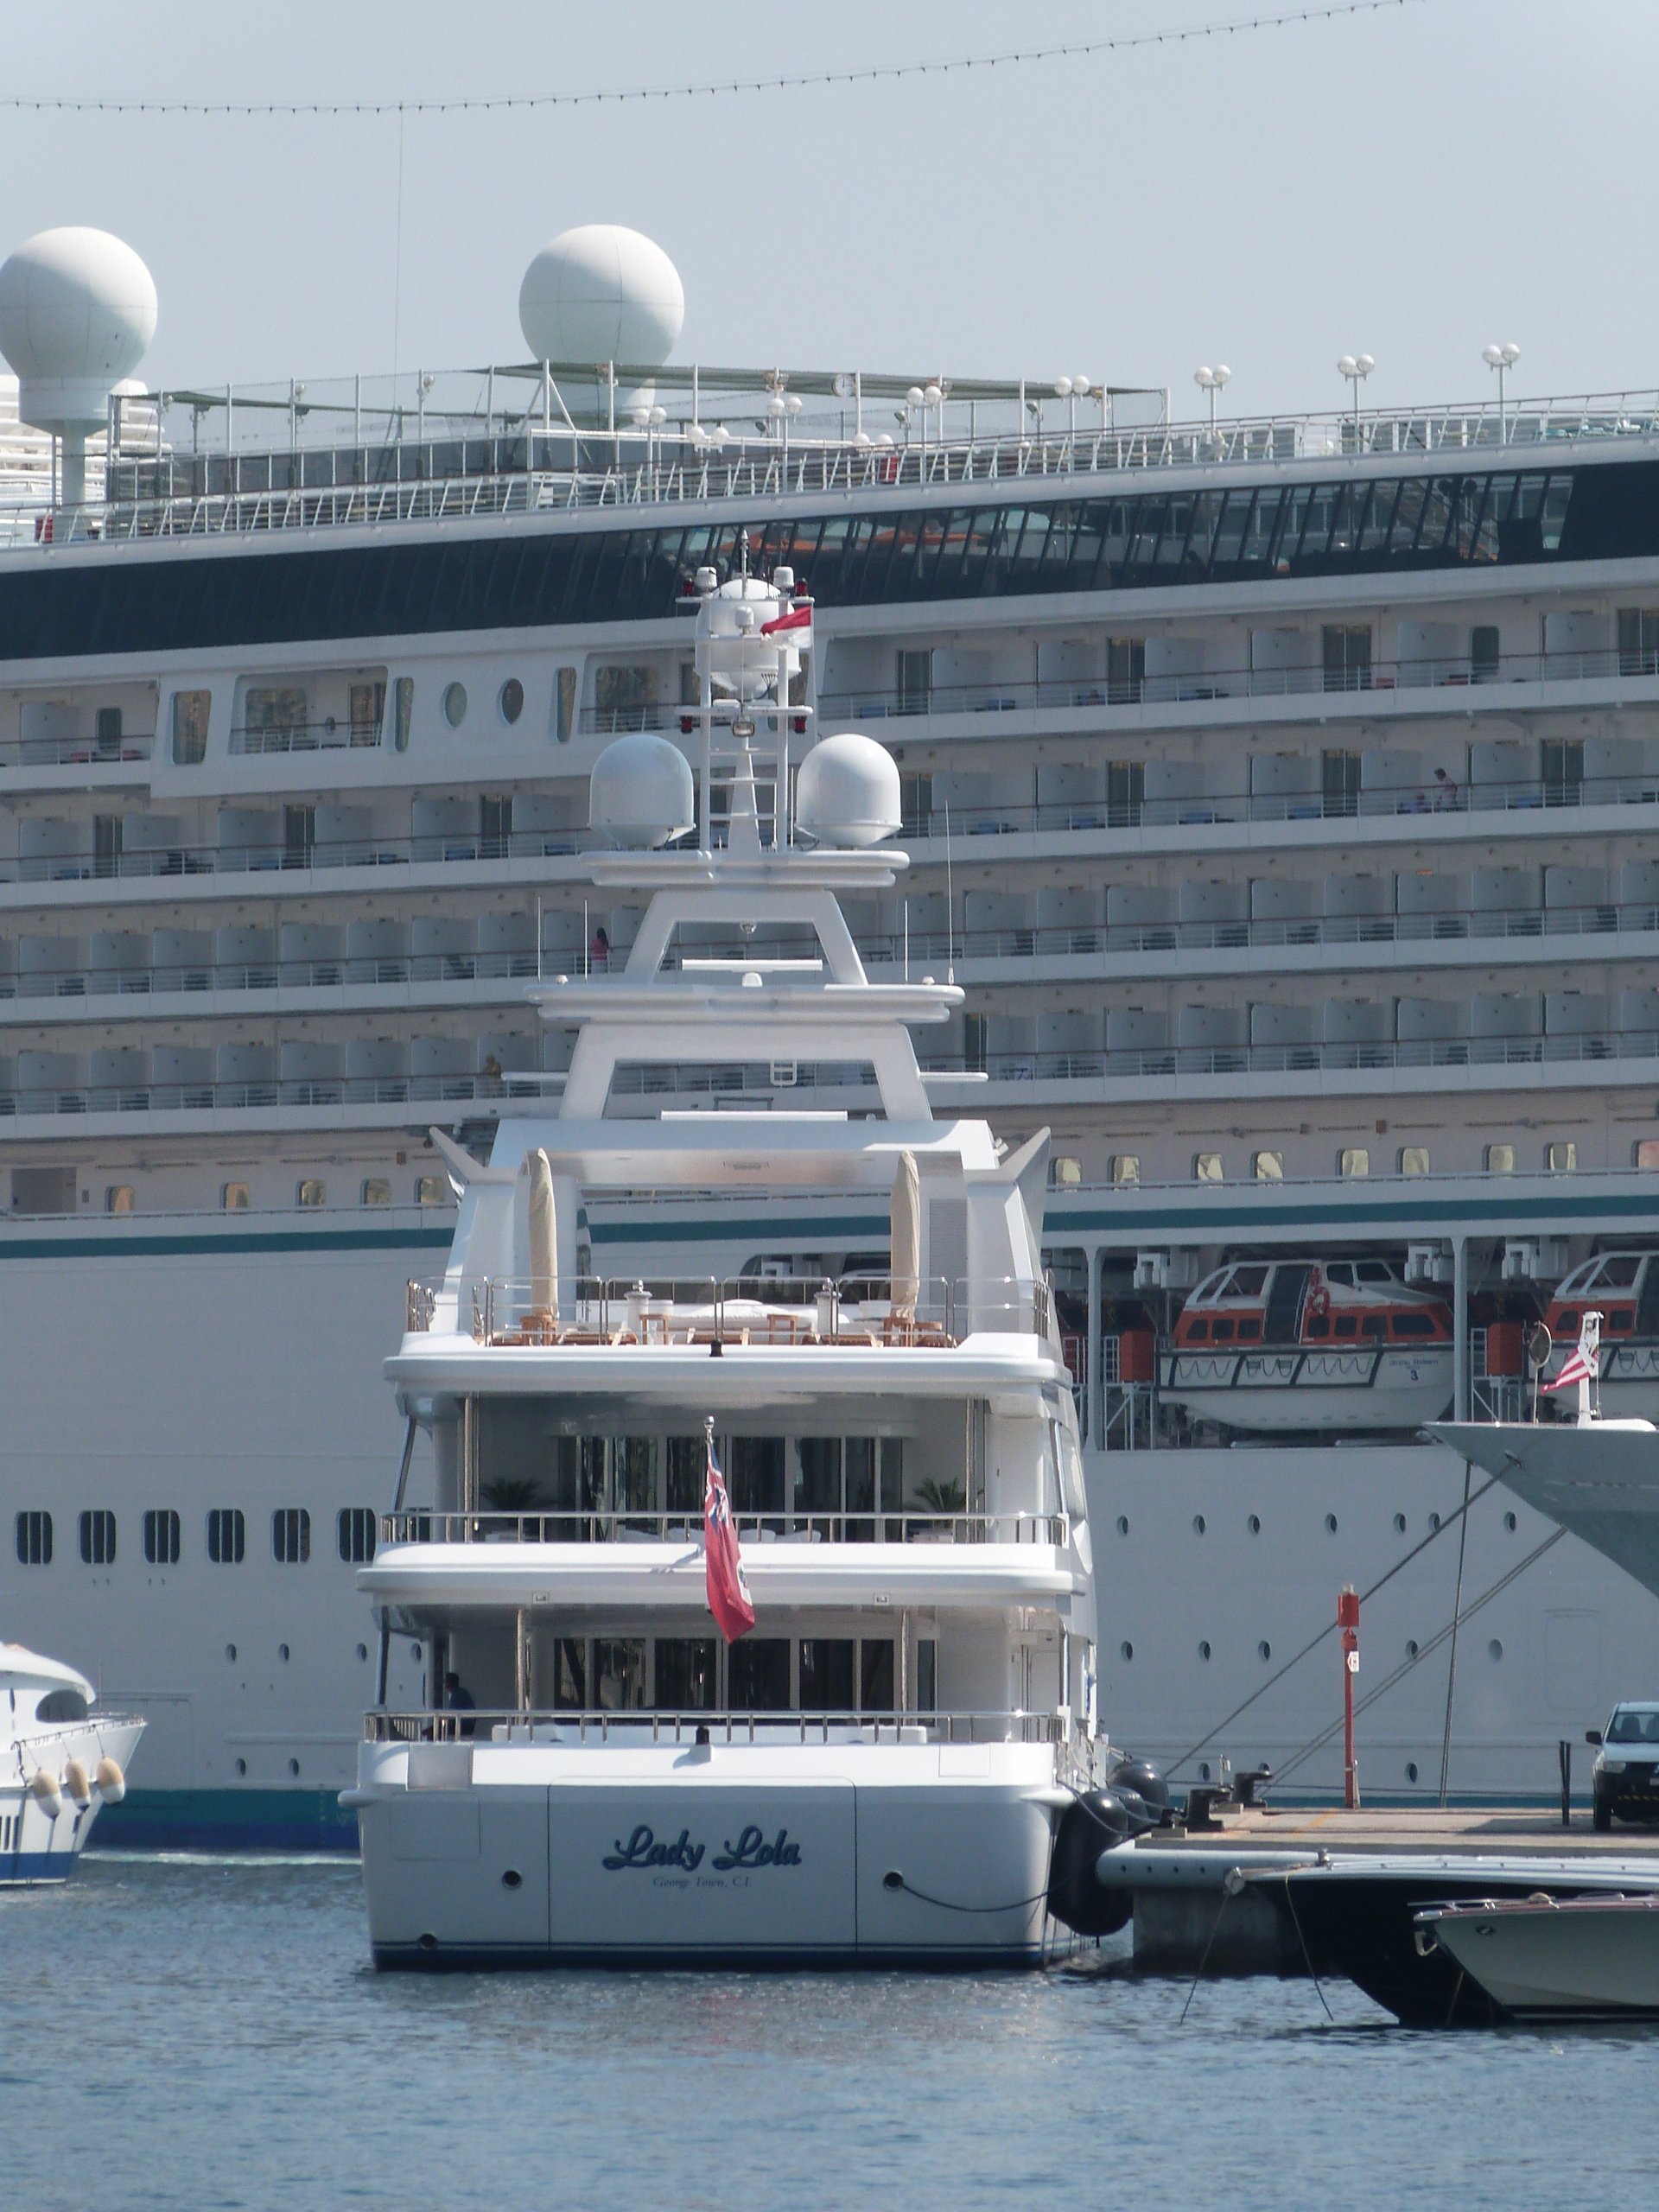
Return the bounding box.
[0,0,1659,414]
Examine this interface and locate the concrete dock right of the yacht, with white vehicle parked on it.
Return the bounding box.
[1123,1805,1659,1975]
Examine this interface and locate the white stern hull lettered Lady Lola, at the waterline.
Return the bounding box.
[347,1745,1062,1968]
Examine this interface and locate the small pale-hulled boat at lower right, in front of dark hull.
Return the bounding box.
[1415,1896,1659,2019]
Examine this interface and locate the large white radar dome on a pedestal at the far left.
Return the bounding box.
[0,228,155,431]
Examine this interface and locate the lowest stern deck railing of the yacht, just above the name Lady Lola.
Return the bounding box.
[363,1707,1077,1750]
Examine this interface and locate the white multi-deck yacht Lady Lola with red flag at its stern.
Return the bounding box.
[345,566,1110,1964]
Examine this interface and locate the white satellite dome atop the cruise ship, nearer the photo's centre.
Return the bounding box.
[518,224,686,370]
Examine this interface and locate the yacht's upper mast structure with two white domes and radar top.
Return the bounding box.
[555,553,946,1122]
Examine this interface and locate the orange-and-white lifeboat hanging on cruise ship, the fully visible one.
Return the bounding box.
[1159,1259,1453,1435]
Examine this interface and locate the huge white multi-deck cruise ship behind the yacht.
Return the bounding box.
[0,230,1659,1845]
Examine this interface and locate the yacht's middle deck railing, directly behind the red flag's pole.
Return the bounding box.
[380,1504,1071,1548]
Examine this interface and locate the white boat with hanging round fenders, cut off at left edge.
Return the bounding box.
[0,1643,143,1889]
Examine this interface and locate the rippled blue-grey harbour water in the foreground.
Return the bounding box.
[0,1858,1659,2212]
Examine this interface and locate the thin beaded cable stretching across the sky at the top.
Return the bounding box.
[0,0,1421,118]
